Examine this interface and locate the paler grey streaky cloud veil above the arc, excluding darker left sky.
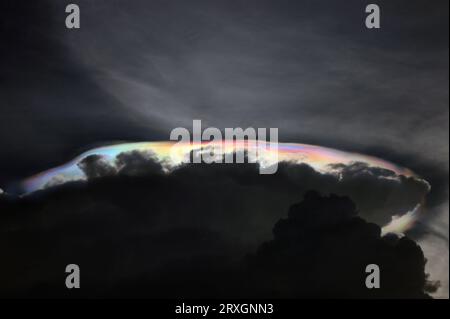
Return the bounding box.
[58,1,448,238]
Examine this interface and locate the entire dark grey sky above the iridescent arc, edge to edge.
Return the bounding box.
[0,0,449,298]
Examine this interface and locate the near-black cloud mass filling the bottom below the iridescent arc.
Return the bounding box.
[0,159,436,297]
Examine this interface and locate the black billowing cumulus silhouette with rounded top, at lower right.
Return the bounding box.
[244,192,436,298]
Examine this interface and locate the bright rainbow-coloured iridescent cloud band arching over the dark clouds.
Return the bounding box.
[16,141,424,233]
